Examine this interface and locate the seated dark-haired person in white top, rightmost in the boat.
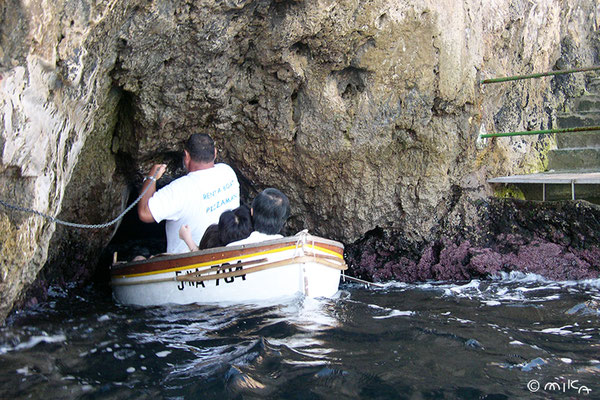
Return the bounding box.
[227,188,290,246]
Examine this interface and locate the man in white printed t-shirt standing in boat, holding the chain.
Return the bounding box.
[138,133,240,253]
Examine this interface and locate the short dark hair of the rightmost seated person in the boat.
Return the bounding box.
[252,188,290,235]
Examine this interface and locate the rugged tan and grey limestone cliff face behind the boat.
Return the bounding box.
[0,0,598,318]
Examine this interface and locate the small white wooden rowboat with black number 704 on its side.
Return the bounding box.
[111,232,347,306]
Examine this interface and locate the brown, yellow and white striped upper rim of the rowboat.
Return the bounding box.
[110,234,344,277]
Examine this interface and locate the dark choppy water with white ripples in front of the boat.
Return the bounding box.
[0,275,600,400]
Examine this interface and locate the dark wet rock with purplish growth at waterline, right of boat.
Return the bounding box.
[346,199,600,282]
